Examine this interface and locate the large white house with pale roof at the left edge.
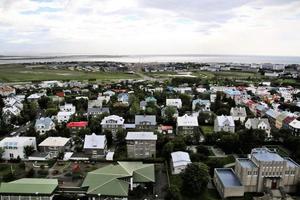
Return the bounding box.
[0,136,36,160]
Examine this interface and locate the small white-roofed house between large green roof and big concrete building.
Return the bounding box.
[171,151,192,174]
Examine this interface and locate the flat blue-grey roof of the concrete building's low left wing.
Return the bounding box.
[215,168,242,187]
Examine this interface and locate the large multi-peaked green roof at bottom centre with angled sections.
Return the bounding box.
[82,162,155,197]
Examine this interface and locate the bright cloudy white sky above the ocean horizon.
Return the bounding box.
[0,0,300,56]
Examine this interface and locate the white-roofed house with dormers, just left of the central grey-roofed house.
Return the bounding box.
[101,115,125,138]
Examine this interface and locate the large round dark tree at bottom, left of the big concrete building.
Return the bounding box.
[181,163,209,197]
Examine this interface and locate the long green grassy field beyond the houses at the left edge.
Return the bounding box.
[0,66,140,82]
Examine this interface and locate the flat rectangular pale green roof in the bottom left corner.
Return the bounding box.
[0,178,58,195]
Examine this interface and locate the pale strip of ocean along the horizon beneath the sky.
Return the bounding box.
[0,55,300,64]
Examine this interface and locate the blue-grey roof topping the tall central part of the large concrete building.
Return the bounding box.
[251,147,284,162]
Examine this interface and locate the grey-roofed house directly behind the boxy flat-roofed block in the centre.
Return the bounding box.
[134,115,156,130]
